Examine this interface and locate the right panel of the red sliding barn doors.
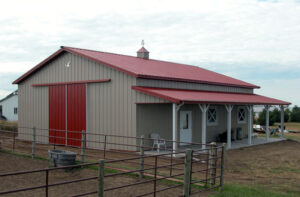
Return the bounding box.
[67,84,86,146]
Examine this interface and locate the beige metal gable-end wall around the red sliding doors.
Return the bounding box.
[19,53,136,148]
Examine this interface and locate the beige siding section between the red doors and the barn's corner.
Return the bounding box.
[88,71,136,149]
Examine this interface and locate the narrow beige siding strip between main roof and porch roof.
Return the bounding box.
[136,78,253,93]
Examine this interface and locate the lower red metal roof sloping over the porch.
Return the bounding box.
[132,86,291,105]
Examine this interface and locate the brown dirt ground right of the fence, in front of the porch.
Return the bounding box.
[225,140,300,194]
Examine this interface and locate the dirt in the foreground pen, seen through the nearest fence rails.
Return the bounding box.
[0,152,186,196]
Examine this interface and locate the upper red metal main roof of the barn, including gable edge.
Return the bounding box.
[13,47,259,88]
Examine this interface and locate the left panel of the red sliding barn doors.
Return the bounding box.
[49,86,66,144]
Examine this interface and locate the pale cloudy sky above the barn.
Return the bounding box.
[0,0,300,106]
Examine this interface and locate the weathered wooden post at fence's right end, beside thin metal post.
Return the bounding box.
[208,142,218,185]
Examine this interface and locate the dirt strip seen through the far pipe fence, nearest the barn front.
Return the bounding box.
[0,137,211,186]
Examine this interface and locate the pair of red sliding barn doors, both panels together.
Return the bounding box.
[49,84,86,146]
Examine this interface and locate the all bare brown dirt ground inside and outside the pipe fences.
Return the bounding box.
[0,134,300,196]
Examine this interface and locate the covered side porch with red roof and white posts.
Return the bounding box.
[133,87,290,151]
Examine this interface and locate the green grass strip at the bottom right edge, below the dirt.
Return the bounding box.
[210,184,296,197]
